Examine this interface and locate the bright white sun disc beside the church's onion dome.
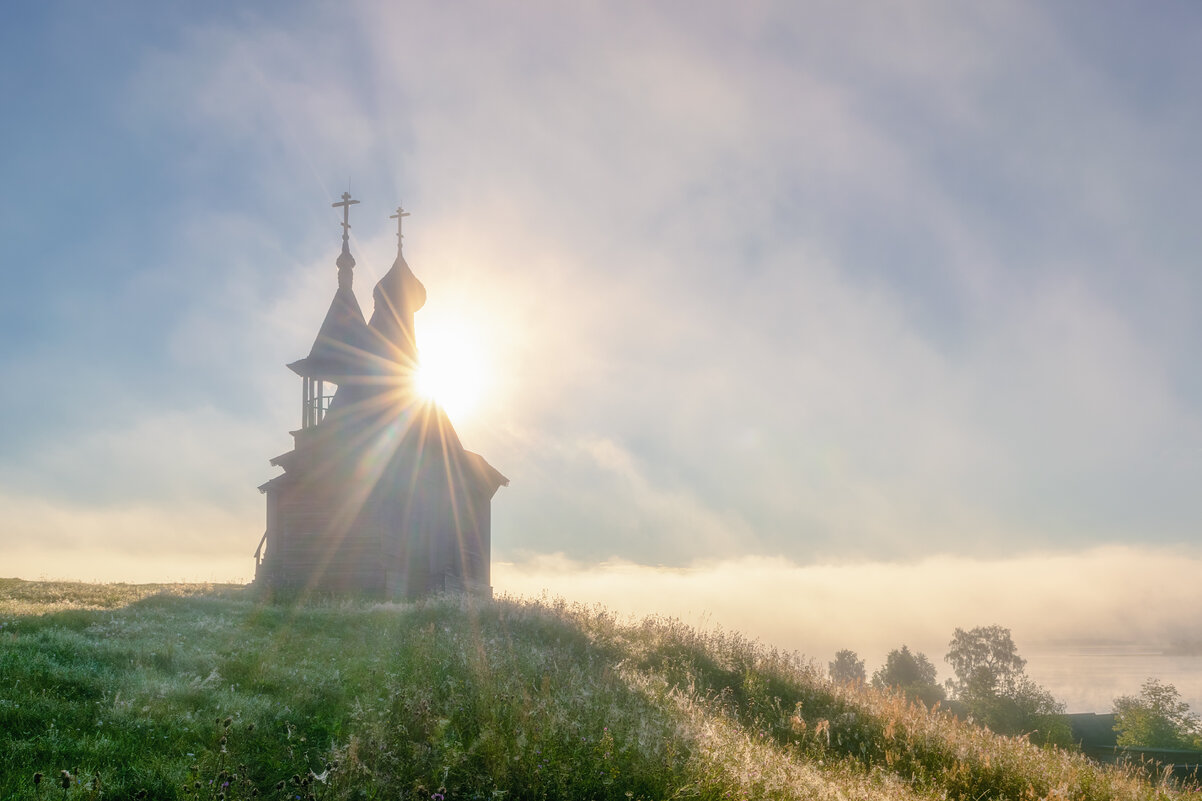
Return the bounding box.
[416,321,490,420]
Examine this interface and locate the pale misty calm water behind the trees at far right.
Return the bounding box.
[1023,645,1202,714]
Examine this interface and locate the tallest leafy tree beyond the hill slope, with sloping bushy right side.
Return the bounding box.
[946,625,1072,746]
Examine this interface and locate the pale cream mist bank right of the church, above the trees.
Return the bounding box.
[493,546,1202,712]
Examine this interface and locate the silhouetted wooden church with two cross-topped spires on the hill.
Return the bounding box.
[255,192,508,591]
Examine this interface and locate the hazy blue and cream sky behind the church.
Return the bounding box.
[0,0,1202,699]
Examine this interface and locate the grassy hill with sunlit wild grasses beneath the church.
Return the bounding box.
[0,580,1185,801]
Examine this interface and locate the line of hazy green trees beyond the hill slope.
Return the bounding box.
[828,625,1202,749]
